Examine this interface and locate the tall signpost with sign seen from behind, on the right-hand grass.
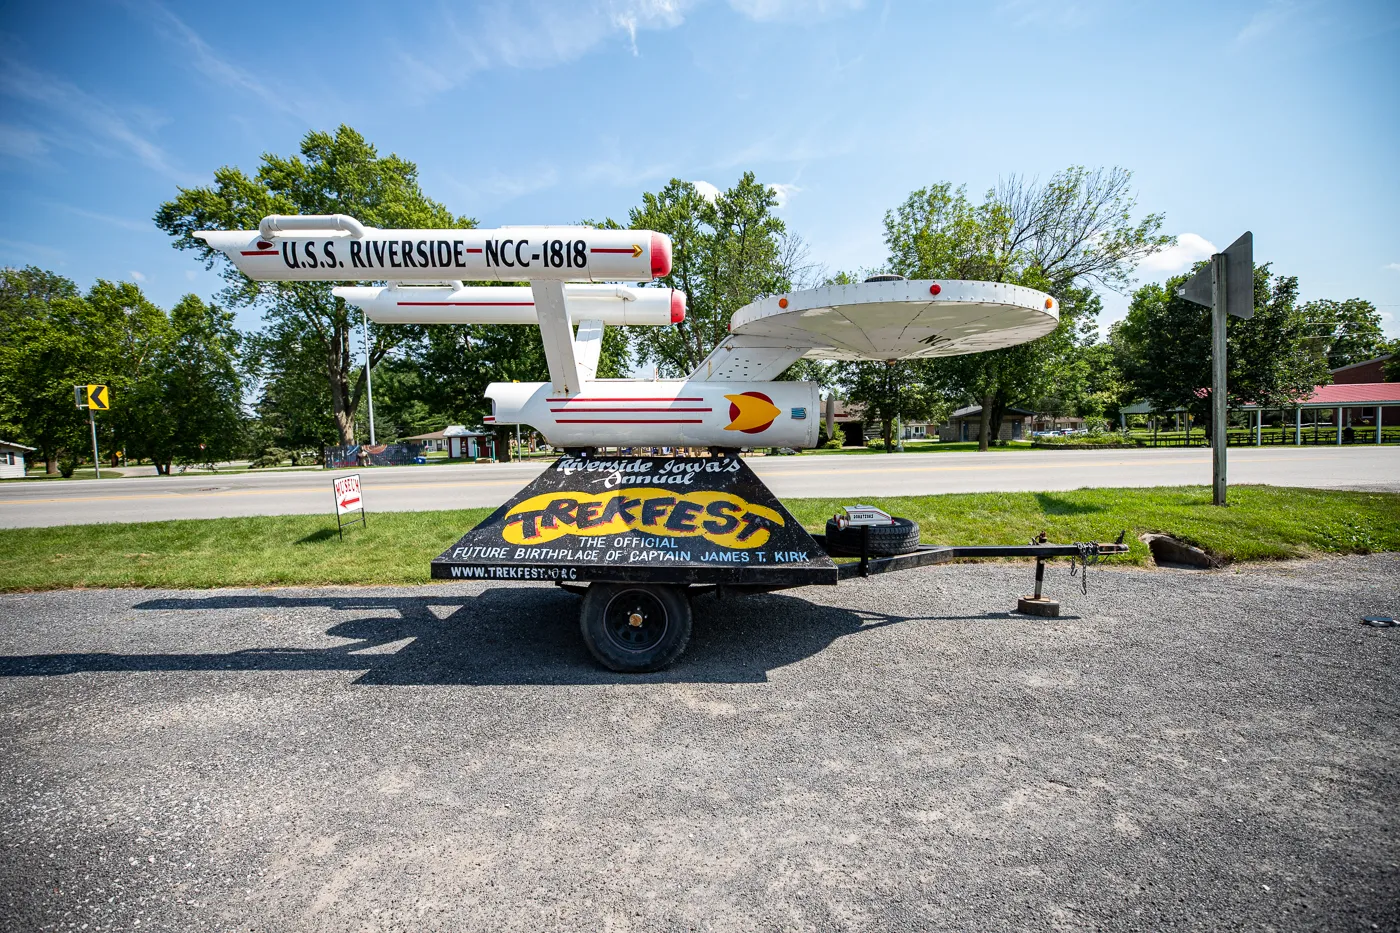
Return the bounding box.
[1177,231,1254,506]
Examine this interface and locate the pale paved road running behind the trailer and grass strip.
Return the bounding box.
[0,447,1400,528]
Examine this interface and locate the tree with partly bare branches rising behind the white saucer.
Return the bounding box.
[885,165,1172,450]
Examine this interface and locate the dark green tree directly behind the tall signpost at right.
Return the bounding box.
[1110,265,1327,420]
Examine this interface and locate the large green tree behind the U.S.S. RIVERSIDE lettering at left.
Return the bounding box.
[155,126,476,444]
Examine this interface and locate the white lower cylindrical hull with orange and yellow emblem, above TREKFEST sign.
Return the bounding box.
[484,380,820,447]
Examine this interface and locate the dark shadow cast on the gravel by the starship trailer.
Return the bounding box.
[0,587,1052,685]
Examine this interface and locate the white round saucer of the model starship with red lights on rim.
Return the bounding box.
[729,280,1060,360]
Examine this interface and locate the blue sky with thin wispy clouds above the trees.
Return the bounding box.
[0,0,1400,336]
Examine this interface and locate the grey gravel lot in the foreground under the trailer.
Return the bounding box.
[0,555,1400,933]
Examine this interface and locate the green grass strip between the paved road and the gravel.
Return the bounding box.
[0,486,1400,591]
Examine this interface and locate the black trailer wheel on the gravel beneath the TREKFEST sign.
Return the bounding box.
[578,583,690,674]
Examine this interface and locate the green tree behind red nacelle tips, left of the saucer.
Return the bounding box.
[621,172,808,375]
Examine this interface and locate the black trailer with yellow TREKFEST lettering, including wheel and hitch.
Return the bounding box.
[433,450,1127,672]
